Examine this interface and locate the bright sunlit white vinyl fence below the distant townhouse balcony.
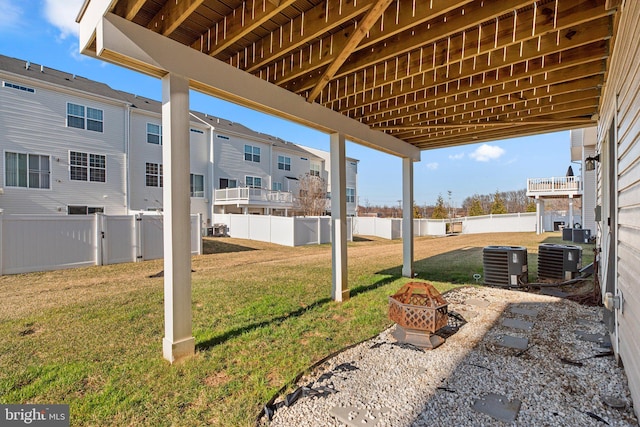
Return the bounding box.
[213,214,353,246]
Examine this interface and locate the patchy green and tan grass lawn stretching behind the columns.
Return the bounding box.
[0,233,593,426]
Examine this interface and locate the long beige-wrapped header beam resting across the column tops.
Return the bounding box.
[95,13,420,161]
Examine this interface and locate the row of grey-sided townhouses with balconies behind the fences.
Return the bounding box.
[0,55,358,226]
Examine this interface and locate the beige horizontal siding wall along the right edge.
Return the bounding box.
[598,0,640,413]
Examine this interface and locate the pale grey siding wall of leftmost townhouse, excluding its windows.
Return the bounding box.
[0,74,127,215]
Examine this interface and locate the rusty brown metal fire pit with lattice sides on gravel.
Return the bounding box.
[389,282,448,350]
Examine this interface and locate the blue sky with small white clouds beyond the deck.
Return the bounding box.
[0,0,579,206]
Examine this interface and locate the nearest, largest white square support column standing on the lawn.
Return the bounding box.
[162,74,195,363]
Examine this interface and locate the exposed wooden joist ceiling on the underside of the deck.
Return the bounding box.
[91,0,621,149]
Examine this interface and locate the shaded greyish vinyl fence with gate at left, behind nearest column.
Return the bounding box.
[0,212,202,275]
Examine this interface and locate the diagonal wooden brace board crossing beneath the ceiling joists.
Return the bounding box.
[307,0,393,102]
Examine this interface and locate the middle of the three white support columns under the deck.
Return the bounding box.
[331,133,349,301]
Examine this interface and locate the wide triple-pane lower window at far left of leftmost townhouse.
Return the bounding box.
[5,152,51,188]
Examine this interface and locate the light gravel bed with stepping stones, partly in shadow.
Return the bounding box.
[259,287,638,427]
